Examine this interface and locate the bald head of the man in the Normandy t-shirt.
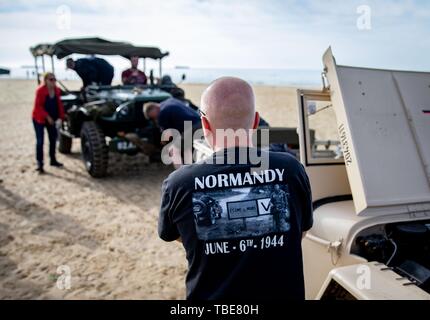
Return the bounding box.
[200,77,259,147]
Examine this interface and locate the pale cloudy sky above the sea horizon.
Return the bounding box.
[0,0,430,70]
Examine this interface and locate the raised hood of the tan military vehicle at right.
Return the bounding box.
[323,48,430,216]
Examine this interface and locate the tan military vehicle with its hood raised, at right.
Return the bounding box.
[194,49,430,300]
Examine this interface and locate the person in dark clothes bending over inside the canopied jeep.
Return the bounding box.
[66,57,114,87]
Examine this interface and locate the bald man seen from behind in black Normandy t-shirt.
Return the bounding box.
[158,77,313,300]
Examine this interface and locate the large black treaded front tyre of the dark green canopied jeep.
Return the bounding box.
[81,121,109,178]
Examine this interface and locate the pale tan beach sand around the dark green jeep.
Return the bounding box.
[0,79,306,299]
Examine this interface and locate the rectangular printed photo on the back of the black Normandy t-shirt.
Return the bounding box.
[192,184,290,240]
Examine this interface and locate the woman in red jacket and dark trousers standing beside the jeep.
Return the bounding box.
[33,72,64,173]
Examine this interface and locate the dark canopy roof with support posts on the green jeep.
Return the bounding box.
[30,38,169,83]
